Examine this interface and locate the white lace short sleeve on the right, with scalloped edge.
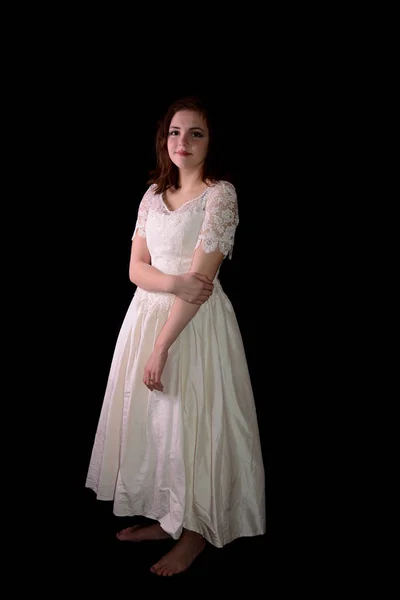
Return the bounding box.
[196,182,239,258]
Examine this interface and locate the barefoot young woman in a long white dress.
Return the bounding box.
[86,98,265,575]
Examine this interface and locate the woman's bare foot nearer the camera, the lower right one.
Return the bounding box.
[150,529,206,577]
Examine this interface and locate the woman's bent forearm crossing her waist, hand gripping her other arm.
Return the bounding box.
[129,235,214,307]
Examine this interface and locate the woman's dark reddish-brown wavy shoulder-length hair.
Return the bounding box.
[147,96,231,194]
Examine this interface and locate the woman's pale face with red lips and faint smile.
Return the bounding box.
[167,110,209,170]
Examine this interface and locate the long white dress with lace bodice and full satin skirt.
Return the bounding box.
[86,181,265,547]
